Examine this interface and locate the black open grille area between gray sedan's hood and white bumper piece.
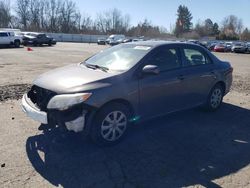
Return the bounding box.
[28,85,56,112]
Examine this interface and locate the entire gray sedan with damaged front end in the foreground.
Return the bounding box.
[22,41,233,145]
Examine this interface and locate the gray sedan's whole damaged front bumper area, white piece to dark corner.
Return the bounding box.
[21,94,93,132]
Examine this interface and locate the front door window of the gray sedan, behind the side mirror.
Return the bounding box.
[148,48,181,71]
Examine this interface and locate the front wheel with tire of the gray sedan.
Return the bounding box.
[90,103,130,146]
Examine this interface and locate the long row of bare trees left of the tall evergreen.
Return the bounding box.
[0,0,165,36]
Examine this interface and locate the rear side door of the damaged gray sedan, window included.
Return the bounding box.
[182,45,216,107]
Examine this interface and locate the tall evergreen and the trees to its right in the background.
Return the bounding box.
[174,5,250,40]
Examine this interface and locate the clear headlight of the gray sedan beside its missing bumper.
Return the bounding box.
[47,93,92,110]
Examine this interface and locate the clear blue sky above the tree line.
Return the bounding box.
[73,0,250,31]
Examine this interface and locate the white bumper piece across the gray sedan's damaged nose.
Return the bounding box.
[21,94,48,124]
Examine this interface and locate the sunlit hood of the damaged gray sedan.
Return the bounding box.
[33,64,117,94]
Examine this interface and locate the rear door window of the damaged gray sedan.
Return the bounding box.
[184,49,211,66]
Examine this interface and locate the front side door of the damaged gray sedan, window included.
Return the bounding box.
[139,46,188,118]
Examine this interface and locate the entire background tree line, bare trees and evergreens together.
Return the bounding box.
[0,0,250,40]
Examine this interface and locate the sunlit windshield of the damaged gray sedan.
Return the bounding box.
[85,44,151,71]
